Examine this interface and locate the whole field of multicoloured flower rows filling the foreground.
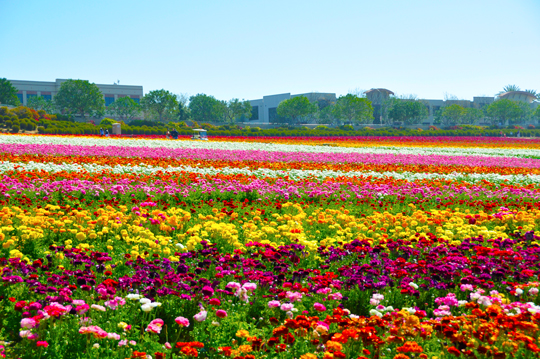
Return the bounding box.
[0,135,540,359]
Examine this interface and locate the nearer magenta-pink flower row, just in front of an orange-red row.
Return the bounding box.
[0,173,540,201]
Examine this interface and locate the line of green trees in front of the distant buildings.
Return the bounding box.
[0,79,540,128]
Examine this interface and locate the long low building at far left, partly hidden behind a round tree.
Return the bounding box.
[9,79,143,106]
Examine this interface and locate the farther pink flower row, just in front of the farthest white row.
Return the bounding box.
[0,144,540,168]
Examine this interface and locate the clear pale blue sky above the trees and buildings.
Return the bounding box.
[0,0,540,100]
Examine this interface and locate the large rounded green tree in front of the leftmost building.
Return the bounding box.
[54,80,105,117]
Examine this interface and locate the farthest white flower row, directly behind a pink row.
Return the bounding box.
[0,135,540,158]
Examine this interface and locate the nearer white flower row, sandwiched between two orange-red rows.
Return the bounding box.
[0,161,540,184]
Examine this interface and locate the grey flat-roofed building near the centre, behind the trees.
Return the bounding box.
[249,92,336,124]
